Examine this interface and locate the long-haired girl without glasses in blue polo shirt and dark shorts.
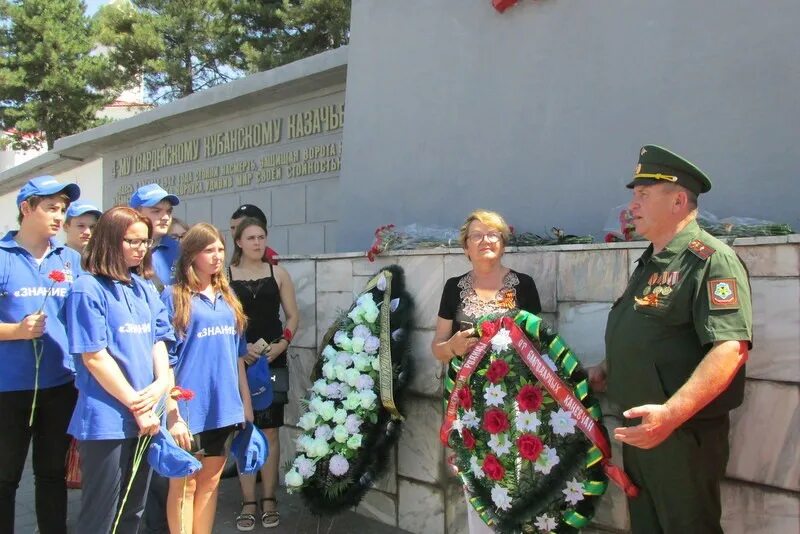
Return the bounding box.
[162,223,253,533]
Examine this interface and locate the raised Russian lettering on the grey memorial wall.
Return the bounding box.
[107,103,344,204]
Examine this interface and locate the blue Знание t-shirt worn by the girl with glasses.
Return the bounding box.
[66,274,174,440]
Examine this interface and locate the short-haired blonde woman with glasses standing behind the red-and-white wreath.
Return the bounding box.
[431,210,542,534]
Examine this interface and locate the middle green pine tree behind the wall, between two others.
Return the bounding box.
[97,0,239,101]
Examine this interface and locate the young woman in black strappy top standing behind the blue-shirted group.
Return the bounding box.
[230,217,299,531]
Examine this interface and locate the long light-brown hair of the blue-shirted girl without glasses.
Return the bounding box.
[167,223,247,336]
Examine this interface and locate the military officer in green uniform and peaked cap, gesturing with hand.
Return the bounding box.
[590,145,752,534]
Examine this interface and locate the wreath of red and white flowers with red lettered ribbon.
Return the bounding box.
[440,311,637,532]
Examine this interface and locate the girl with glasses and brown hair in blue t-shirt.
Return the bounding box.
[66,206,173,533]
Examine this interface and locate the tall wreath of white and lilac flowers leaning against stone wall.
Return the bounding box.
[285,265,413,513]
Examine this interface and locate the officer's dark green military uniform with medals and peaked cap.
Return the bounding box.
[606,146,752,534]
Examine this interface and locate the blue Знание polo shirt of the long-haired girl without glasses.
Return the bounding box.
[161,287,247,434]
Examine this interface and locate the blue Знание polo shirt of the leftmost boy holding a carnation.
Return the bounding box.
[0,231,83,391]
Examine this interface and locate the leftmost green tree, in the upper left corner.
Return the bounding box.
[0,0,124,149]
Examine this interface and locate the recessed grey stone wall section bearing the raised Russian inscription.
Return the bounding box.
[103,91,344,254]
